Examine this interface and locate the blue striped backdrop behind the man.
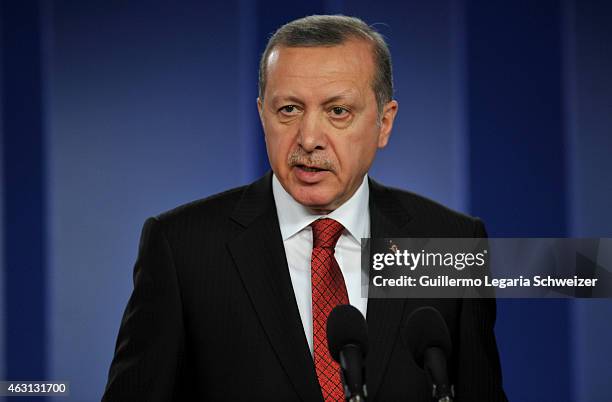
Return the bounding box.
[0,0,612,402]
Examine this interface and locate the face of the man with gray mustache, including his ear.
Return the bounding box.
[257,40,397,213]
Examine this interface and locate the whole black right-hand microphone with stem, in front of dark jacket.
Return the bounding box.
[406,306,455,402]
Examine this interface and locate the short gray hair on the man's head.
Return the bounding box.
[259,15,393,114]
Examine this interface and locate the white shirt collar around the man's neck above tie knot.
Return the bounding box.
[272,174,370,242]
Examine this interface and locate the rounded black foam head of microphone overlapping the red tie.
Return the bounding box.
[327,304,368,362]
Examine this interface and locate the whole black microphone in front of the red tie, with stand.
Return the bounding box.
[327,304,368,402]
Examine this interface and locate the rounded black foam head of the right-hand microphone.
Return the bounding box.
[405,306,452,368]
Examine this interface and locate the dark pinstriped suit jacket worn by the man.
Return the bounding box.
[103,173,506,402]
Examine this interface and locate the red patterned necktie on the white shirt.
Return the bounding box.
[310,218,349,401]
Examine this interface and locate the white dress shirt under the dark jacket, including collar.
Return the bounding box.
[272,175,370,353]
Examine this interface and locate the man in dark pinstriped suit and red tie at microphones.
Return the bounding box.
[103,16,505,401]
